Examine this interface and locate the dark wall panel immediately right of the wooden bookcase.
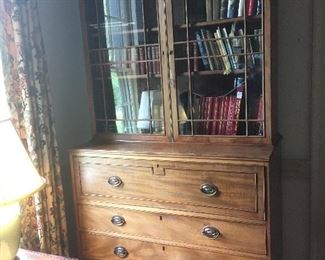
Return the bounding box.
[277,0,312,260]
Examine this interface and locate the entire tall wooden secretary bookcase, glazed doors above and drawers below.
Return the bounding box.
[70,0,281,260]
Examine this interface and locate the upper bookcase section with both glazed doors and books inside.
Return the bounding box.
[81,0,273,143]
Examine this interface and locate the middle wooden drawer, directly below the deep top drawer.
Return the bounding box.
[79,205,266,255]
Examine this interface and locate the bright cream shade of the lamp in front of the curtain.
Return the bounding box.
[0,119,45,206]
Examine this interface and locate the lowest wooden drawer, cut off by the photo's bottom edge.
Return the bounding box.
[80,232,267,260]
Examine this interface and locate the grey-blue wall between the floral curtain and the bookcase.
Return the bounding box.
[39,0,91,255]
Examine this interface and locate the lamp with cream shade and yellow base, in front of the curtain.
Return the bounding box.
[0,119,45,260]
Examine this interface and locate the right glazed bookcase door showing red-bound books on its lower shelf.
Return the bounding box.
[166,0,270,142]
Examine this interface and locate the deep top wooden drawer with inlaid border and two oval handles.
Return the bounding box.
[76,159,265,219]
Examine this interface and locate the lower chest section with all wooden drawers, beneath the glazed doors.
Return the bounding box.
[71,145,276,260]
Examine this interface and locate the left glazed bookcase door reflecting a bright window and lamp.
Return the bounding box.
[82,0,166,139]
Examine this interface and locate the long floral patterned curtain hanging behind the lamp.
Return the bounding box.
[0,0,68,255]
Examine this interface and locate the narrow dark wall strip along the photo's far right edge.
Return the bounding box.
[310,0,325,260]
